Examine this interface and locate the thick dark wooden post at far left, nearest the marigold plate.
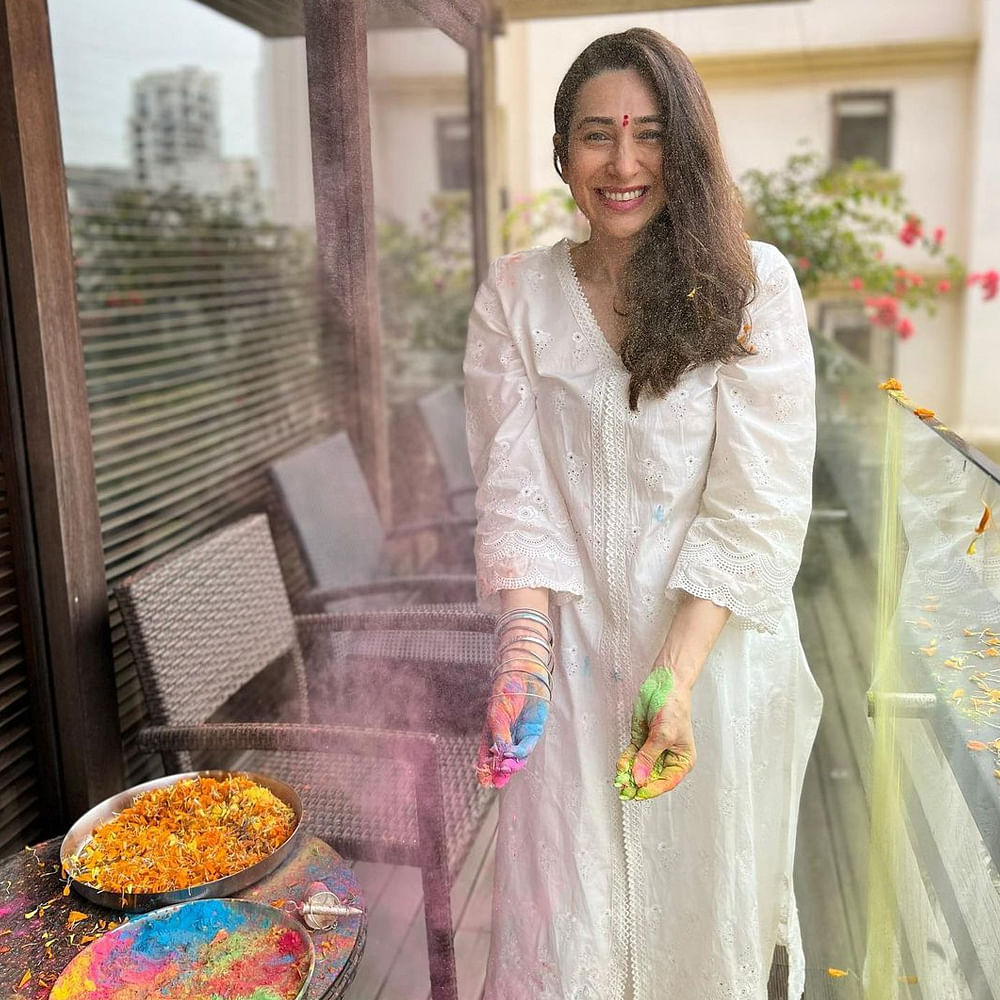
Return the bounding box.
[0,0,124,814]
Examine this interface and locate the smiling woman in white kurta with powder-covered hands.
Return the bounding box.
[465,23,821,1000]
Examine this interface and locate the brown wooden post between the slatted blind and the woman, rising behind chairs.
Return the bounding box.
[304,0,392,523]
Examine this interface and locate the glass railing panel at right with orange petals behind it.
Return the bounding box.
[804,342,1000,1000]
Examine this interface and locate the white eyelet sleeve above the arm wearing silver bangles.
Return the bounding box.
[463,258,583,611]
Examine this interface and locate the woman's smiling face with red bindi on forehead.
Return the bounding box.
[563,69,667,239]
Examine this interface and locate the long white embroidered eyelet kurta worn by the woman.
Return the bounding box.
[465,240,822,1000]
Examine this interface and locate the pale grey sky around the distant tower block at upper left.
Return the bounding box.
[48,0,261,167]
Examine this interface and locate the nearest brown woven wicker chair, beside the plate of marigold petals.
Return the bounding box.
[116,515,492,1000]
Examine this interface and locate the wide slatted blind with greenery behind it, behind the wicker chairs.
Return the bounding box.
[72,191,348,781]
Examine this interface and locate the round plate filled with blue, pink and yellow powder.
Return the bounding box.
[51,899,315,1000]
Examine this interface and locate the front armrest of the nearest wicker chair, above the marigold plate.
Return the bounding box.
[138,722,438,763]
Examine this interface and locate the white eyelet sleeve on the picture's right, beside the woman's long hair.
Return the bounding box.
[668,246,816,632]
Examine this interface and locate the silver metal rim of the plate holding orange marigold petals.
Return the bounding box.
[59,771,302,911]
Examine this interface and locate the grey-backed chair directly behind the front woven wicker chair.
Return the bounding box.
[268,431,476,611]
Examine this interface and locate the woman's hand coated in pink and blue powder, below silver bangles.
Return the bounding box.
[476,657,551,788]
